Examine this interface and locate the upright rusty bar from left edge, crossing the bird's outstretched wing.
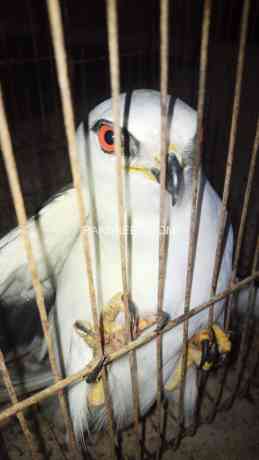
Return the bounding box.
[0,87,80,458]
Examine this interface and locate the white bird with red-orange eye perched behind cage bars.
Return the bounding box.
[0,90,256,437]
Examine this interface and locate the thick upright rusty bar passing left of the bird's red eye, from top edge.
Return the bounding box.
[47,0,116,459]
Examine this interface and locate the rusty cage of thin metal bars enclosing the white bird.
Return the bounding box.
[0,0,259,459]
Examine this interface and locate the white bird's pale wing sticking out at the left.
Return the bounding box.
[0,188,79,306]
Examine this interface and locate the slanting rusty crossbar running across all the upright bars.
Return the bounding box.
[0,270,259,422]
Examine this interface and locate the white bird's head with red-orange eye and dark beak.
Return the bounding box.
[77,90,197,221]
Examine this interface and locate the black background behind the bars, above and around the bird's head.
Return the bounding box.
[0,0,259,275]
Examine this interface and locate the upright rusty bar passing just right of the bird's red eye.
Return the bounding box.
[106,0,141,459]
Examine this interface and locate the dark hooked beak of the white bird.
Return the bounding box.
[151,154,183,206]
